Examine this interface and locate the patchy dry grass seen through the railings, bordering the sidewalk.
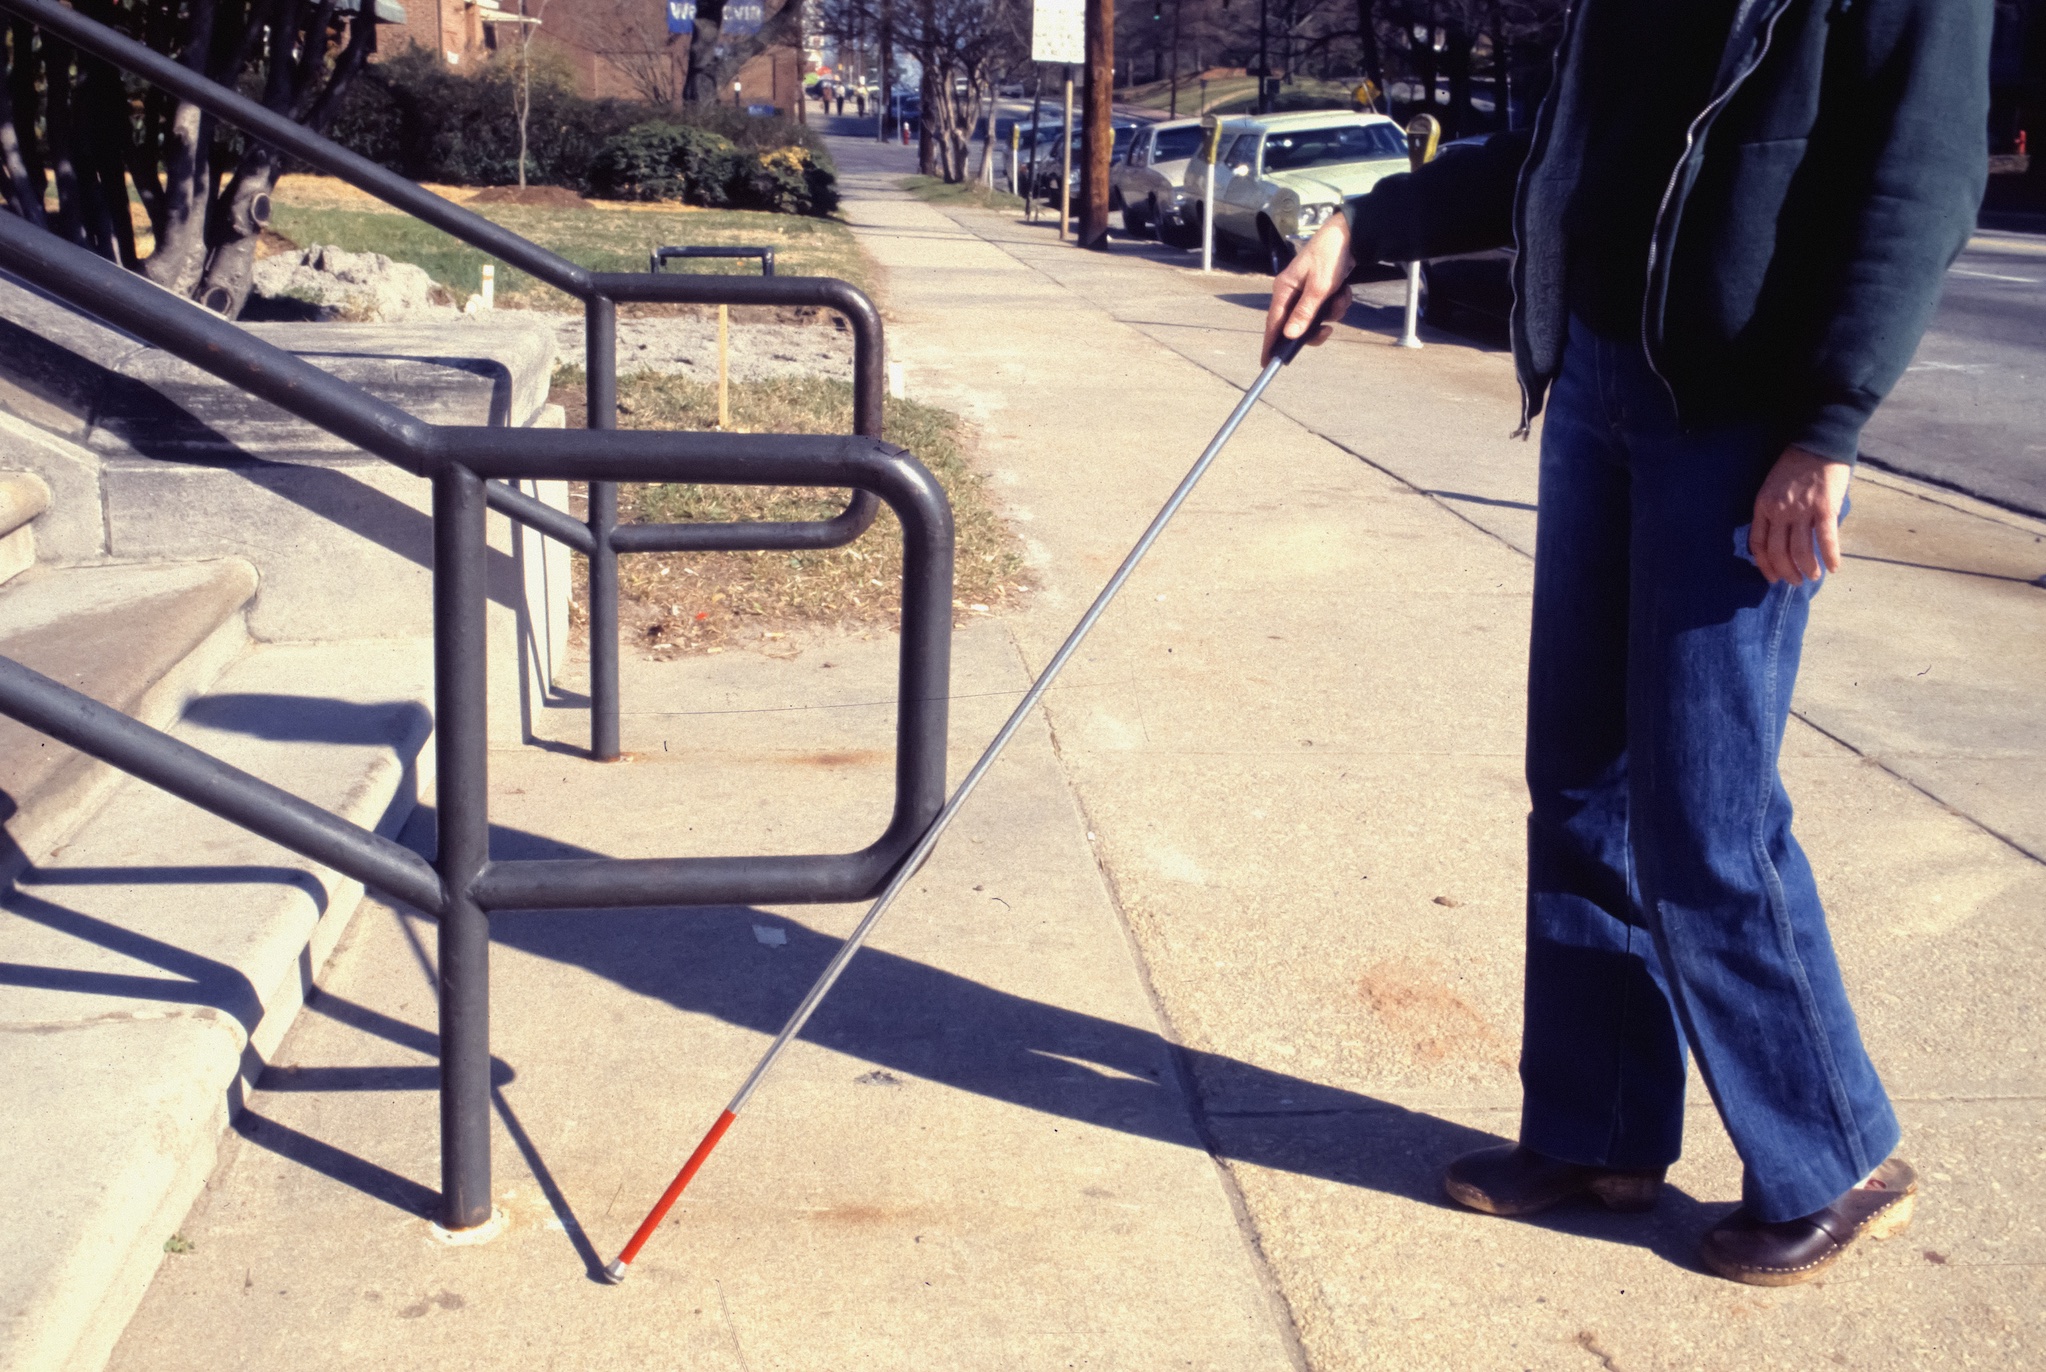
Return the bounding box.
[552,366,1029,656]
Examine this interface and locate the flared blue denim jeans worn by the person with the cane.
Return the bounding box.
[1520,321,1897,1221]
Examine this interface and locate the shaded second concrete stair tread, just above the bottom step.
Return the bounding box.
[0,558,256,879]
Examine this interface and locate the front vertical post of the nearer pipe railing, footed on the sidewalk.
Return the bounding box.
[434,466,491,1231]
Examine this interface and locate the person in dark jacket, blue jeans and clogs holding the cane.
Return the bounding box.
[1264,0,1997,1286]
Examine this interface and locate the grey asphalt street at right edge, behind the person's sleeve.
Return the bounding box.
[1862,233,2046,515]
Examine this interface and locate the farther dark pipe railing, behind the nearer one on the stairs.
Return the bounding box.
[0,0,884,761]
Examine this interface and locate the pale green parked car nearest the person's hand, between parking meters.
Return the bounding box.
[1183,110,1408,274]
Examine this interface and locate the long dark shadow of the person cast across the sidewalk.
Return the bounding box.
[456,809,1717,1264]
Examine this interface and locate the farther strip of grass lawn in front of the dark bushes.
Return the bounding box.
[270,176,870,309]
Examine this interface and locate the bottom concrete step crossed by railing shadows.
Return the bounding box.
[0,640,432,1372]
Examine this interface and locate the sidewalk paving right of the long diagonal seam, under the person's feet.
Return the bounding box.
[826,142,2046,1368]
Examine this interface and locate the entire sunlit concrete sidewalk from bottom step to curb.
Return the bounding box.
[99,133,2046,1372]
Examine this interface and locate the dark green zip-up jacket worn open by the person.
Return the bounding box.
[1346,0,1991,462]
